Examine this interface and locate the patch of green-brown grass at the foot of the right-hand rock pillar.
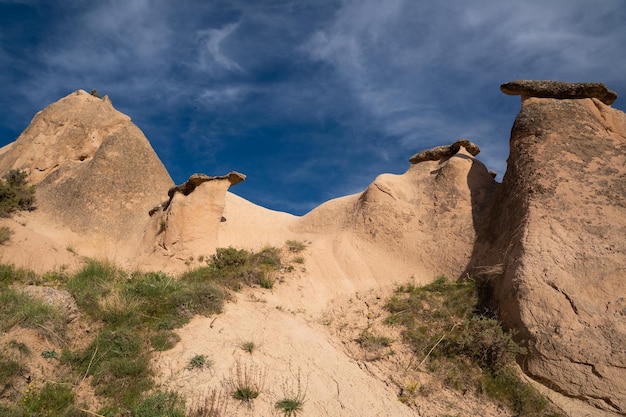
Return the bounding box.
[386,277,556,416]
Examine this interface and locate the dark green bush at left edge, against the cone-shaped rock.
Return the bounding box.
[0,169,35,217]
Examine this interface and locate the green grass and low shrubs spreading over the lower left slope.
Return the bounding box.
[0,247,281,416]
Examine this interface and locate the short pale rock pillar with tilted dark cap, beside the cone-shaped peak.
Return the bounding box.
[141,172,246,259]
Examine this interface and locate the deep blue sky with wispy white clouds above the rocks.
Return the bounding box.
[0,0,626,214]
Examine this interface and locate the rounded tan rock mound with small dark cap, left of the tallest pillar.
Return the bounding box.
[296,141,497,282]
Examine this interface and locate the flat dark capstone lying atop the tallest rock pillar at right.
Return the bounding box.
[500,80,617,105]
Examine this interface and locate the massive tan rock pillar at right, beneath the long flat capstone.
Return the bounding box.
[472,82,626,415]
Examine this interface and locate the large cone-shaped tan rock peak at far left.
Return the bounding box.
[0,90,173,245]
